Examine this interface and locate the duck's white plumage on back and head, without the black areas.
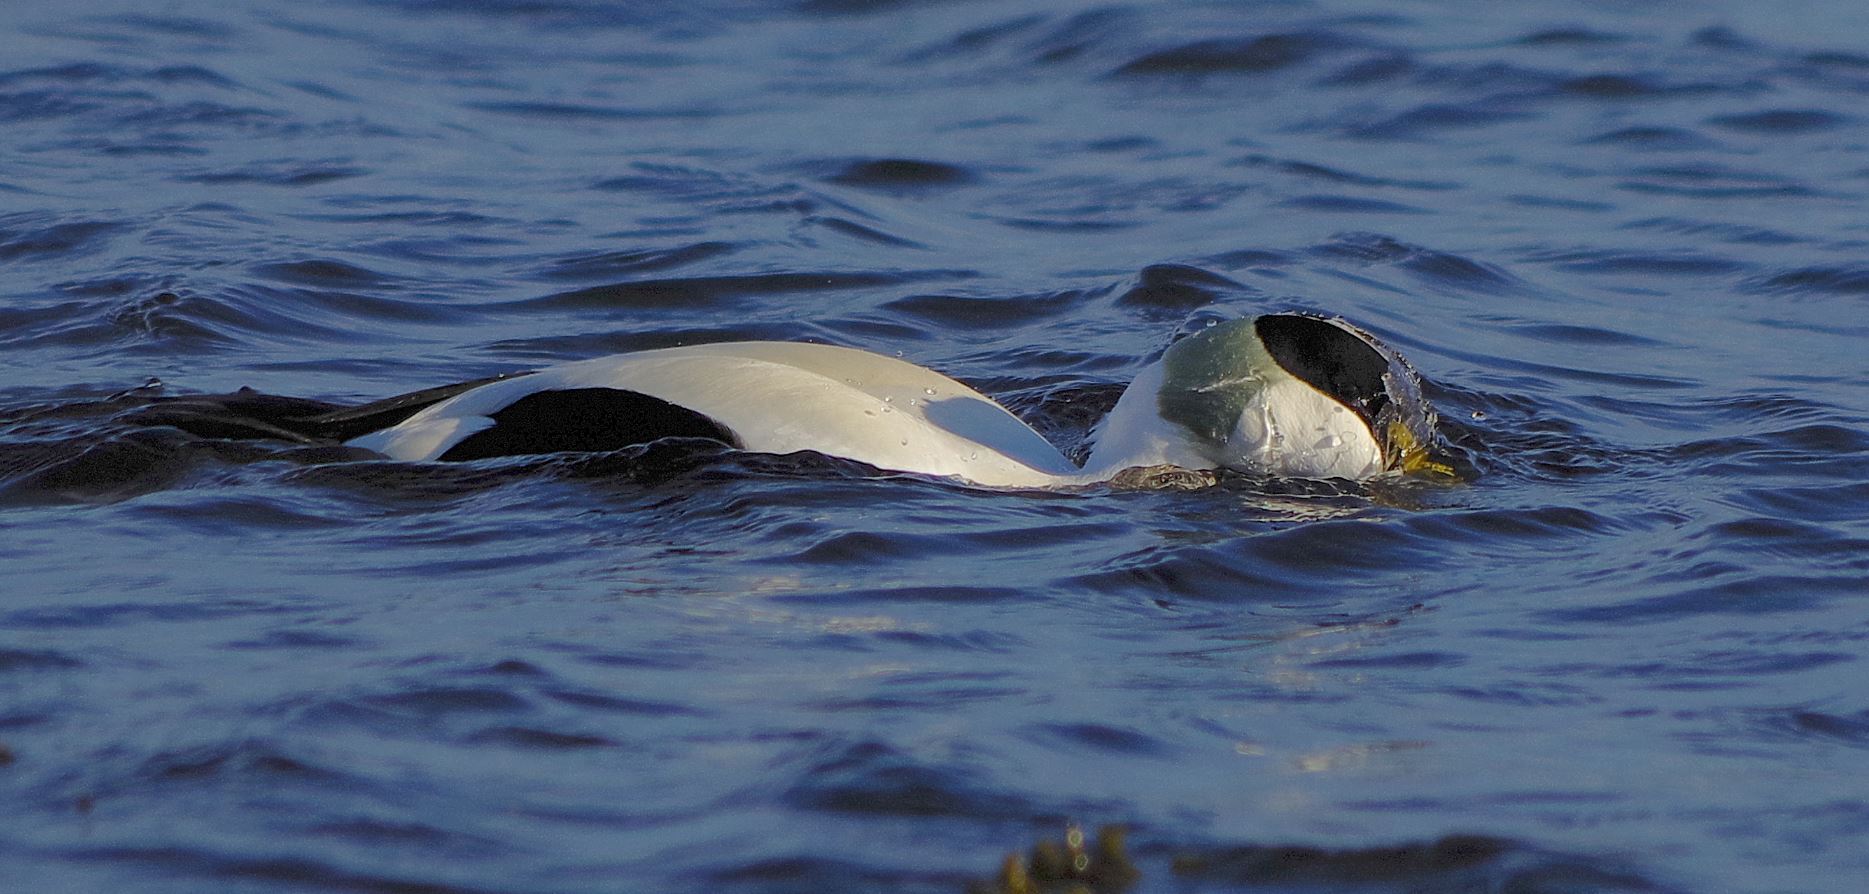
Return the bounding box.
[348,318,1427,488]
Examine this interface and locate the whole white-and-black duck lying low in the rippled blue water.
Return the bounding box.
[346,314,1432,488]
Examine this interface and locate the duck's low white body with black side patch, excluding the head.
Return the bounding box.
[350,342,1078,486]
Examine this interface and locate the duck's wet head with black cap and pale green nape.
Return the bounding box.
[1128,314,1437,479]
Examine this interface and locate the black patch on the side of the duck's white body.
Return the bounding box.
[441,387,740,462]
